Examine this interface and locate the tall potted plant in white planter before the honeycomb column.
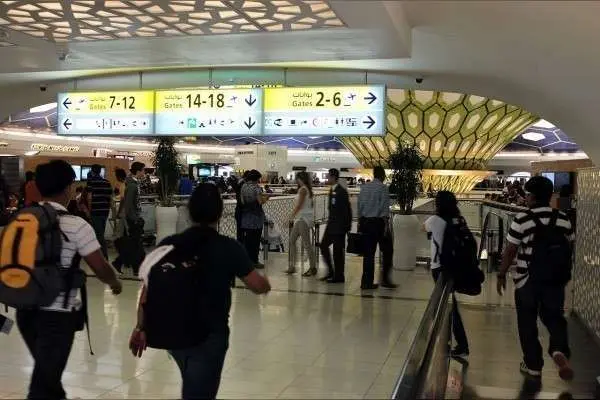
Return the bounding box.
[388,143,423,270]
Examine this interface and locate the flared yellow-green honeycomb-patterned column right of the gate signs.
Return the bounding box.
[342,89,539,170]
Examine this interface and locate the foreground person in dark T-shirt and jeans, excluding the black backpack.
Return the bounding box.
[129,183,271,399]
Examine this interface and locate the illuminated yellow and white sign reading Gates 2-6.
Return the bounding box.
[264,85,385,136]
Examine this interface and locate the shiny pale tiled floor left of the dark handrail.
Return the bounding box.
[0,254,432,399]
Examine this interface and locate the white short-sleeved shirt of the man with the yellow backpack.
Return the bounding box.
[41,202,100,312]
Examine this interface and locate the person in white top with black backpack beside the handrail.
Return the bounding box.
[424,190,482,358]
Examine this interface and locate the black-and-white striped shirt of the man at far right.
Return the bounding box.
[506,207,575,289]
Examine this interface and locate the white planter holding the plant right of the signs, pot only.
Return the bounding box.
[393,214,420,271]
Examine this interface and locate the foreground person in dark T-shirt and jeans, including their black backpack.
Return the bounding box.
[129,183,271,399]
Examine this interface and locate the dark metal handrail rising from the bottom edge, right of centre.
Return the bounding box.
[392,275,452,400]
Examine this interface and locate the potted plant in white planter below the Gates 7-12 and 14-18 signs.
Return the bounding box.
[153,137,181,243]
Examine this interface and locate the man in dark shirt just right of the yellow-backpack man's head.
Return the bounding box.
[87,164,112,257]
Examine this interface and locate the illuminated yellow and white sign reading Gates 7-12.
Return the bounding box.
[58,91,154,136]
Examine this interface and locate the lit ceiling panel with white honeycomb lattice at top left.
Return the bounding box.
[0,0,345,42]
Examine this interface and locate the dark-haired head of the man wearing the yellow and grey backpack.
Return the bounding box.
[35,160,75,206]
